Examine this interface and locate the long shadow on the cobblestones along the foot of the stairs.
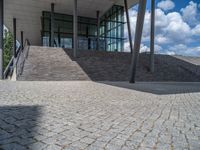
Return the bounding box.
[99,81,200,95]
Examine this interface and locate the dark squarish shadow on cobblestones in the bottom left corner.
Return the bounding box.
[0,106,41,149]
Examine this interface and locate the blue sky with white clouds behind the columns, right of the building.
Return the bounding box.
[125,0,200,57]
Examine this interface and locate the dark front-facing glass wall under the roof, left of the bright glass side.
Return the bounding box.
[42,11,97,49]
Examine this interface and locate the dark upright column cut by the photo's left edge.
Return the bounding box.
[0,0,4,80]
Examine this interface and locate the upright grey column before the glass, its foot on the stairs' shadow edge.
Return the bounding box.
[73,0,78,57]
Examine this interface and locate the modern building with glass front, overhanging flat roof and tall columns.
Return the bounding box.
[0,0,154,81]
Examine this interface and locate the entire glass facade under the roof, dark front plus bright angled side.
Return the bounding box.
[41,5,124,51]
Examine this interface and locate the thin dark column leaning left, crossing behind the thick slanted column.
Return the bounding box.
[124,0,133,53]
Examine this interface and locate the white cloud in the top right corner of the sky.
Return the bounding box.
[181,1,199,25]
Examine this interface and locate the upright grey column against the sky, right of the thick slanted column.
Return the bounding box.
[150,0,155,73]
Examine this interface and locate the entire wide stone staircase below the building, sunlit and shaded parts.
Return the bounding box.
[19,46,200,82]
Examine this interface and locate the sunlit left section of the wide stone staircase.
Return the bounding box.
[19,46,89,81]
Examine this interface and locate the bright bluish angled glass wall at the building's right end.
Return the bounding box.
[100,5,125,51]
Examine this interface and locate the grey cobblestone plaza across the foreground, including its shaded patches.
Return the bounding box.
[0,81,200,150]
